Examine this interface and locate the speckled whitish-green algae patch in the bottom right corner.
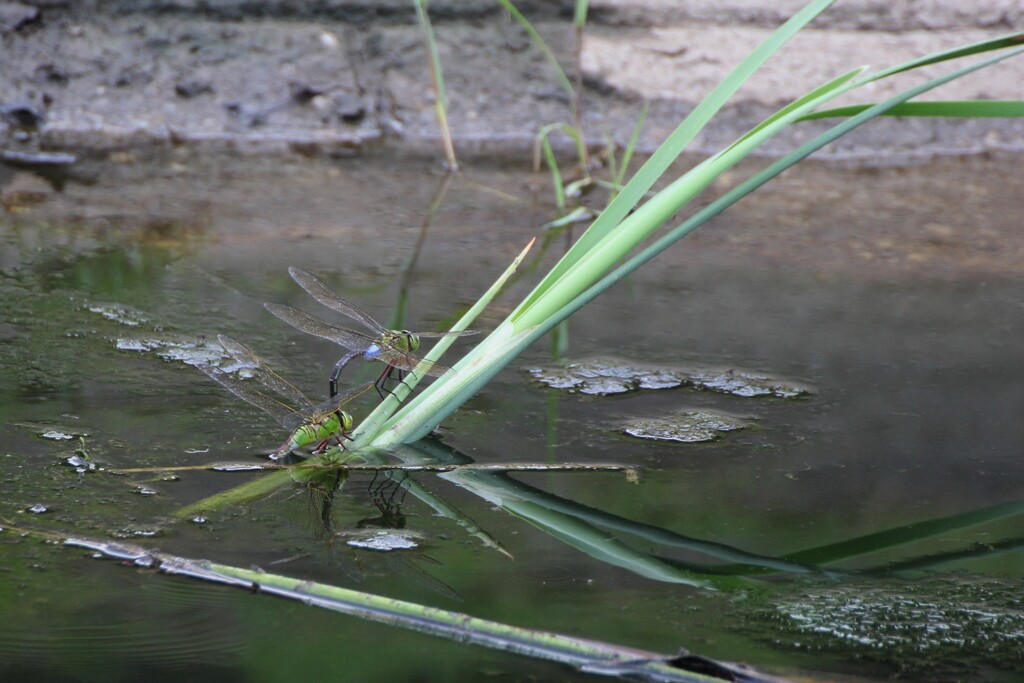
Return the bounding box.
[750,578,1024,681]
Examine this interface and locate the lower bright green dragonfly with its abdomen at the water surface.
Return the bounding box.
[199,335,373,460]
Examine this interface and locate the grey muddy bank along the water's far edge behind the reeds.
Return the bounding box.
[0,0,1024,158]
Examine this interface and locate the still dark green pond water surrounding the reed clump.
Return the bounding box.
[0,151,1024,681]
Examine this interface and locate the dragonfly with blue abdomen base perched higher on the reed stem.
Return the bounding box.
[263,266,477,396]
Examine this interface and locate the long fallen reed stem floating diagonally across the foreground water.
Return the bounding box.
[63,538,777,683]
